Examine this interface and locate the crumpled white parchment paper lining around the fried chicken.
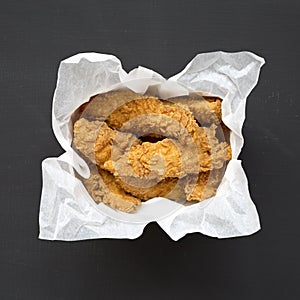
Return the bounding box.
[39,51,264,241]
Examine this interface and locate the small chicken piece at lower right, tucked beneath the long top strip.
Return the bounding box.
[185,168,225,201]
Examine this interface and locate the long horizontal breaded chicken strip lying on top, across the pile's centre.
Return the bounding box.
[103,124,231,179]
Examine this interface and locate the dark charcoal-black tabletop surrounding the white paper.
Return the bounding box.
[0,0,300,300]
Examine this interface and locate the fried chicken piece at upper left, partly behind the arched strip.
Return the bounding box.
[79,89,142,121]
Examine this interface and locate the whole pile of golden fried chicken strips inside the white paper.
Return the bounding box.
[73,90,231,212]
